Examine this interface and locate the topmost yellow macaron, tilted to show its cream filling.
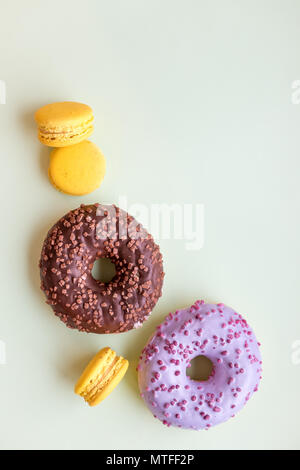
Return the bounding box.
[35,101,94,147]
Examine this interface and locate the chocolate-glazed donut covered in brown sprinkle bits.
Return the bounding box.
[40,204,164,333]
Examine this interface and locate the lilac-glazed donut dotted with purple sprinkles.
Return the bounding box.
[138,300,262,430]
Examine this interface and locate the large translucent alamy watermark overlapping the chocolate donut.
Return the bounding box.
[97,196,204,251]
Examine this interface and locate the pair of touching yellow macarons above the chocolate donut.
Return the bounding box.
[35,101,106,196]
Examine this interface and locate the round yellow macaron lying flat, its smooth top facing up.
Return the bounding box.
[48,140,106,196]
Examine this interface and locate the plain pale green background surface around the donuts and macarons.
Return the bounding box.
[0,0,300,449]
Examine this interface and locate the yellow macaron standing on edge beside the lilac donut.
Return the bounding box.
[75,347,129,406]
